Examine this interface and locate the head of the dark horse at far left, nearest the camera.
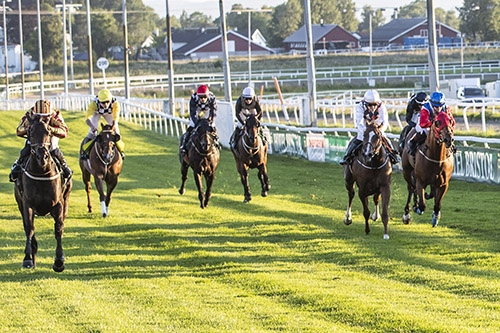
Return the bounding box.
[27,115,52,168]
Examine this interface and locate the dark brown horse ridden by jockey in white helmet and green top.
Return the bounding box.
[231,115,271,202]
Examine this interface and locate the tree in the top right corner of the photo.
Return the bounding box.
[458,0,500,41]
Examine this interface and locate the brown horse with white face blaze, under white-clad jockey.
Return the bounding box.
[343,122,392,239]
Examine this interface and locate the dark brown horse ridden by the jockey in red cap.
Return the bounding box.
[179,118,220,209]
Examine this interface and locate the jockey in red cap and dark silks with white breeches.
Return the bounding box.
[180,84,217,153]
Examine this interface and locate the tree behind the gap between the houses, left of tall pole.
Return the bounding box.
[269,0,304,47]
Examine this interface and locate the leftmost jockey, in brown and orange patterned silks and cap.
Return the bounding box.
[9,100,73,182]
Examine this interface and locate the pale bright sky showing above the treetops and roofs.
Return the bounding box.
[142,0,463,18]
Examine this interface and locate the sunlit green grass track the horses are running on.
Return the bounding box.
[0,112,500,332]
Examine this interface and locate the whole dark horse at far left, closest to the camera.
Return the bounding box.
[14,116,73,272]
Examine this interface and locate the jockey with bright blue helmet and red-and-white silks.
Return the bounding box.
[408,91,455,156]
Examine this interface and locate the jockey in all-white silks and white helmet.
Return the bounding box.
[340,90,400,165]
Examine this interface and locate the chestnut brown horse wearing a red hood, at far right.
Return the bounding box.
[402,112,453,227]
